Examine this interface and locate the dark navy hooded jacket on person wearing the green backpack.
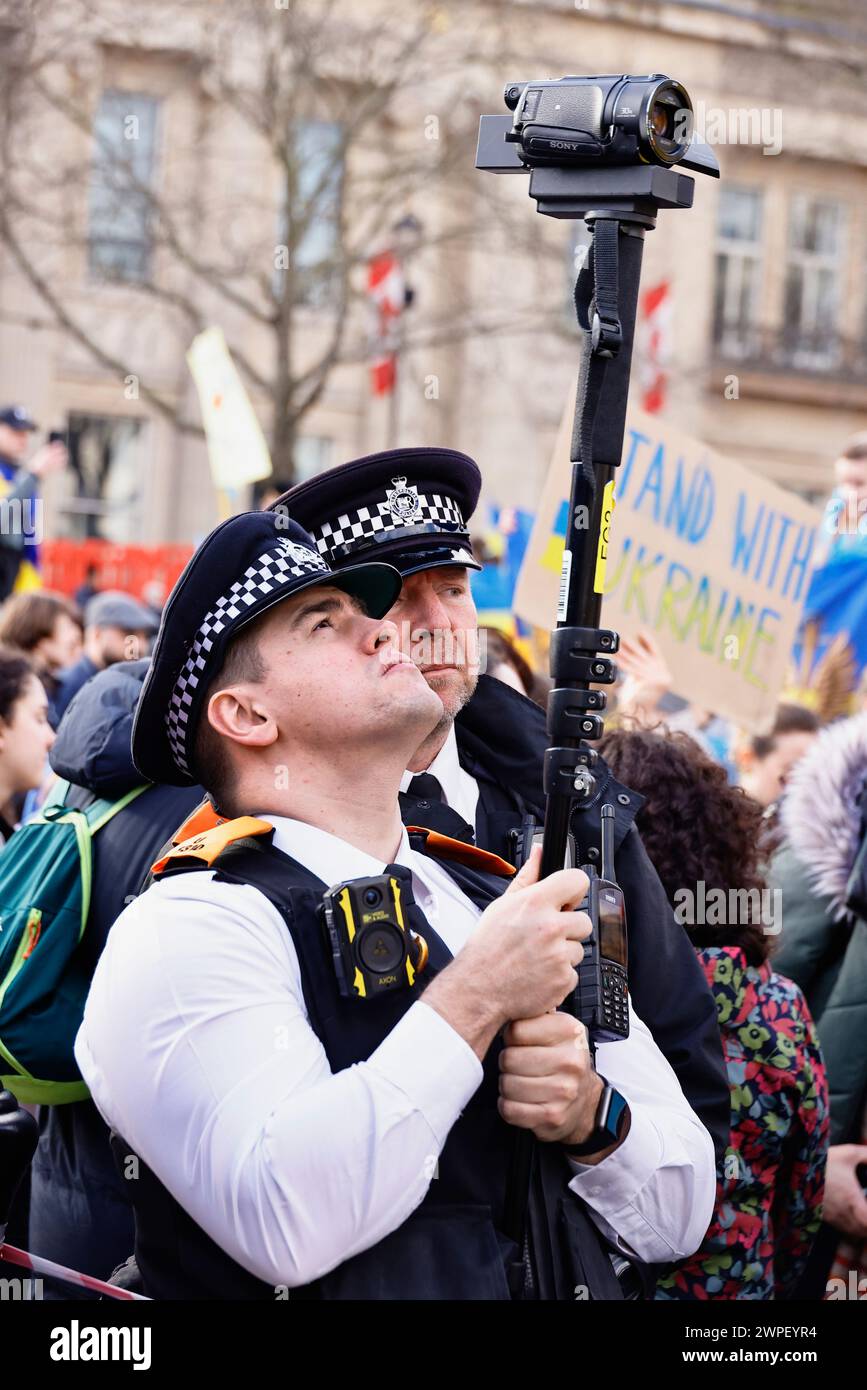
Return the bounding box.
[28,660,203,1279]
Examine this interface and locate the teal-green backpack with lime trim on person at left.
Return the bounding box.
[0,781,150,1105]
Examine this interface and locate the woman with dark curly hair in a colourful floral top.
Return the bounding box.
[600,730,828,1300]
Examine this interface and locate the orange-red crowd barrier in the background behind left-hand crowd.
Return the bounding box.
[39,541,193,607]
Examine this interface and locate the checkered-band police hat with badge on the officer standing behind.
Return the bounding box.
[271,449,482,578]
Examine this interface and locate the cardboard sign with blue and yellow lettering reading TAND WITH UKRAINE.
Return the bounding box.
[514,403,821,733]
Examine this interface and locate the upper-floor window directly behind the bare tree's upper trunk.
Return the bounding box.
[275,121,343,306]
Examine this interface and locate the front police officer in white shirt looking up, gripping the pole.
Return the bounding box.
[76,513,714,1300]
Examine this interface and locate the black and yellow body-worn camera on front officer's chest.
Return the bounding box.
[320,873,428,999]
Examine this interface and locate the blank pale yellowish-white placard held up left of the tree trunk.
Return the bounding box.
[186,328,271,492]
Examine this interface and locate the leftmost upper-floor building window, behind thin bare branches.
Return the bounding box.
[89,92,158,281]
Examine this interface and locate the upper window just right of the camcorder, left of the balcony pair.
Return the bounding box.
[713,186,761,353]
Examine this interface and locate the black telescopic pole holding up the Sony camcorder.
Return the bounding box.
[477,115,718,1297]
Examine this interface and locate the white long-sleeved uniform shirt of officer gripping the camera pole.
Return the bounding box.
[75,816,714,1287]
